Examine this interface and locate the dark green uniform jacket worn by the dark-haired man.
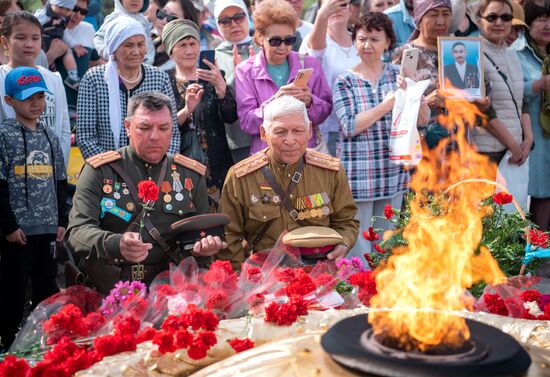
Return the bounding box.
[66,146,209,290]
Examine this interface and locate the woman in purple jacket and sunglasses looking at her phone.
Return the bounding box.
[235,0,332,154]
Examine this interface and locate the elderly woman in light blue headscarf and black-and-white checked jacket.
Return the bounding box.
[76,17,180,159]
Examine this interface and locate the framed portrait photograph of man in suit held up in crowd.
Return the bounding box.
[437,37,485,99]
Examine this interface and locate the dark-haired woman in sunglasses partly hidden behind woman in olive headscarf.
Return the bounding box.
[153,0,199,71]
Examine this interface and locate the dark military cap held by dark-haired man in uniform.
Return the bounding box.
[170,213,231,249]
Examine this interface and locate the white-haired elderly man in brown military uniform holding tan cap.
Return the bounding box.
[217,96,359,268]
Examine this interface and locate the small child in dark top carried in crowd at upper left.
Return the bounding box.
[35,0,80,90]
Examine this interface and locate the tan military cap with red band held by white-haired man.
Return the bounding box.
[283,226,344,262]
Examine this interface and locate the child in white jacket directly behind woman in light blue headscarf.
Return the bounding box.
[94,0,155,64]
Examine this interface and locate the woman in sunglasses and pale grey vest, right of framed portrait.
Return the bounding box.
[473,0,533,165]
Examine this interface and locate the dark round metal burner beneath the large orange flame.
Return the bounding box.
[321,314,531,377]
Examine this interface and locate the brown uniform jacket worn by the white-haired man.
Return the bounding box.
[217,149,359,268]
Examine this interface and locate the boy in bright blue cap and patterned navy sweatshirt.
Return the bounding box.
[0,67,67,348]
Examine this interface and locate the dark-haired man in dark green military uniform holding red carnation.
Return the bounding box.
[66,92,225,293]
